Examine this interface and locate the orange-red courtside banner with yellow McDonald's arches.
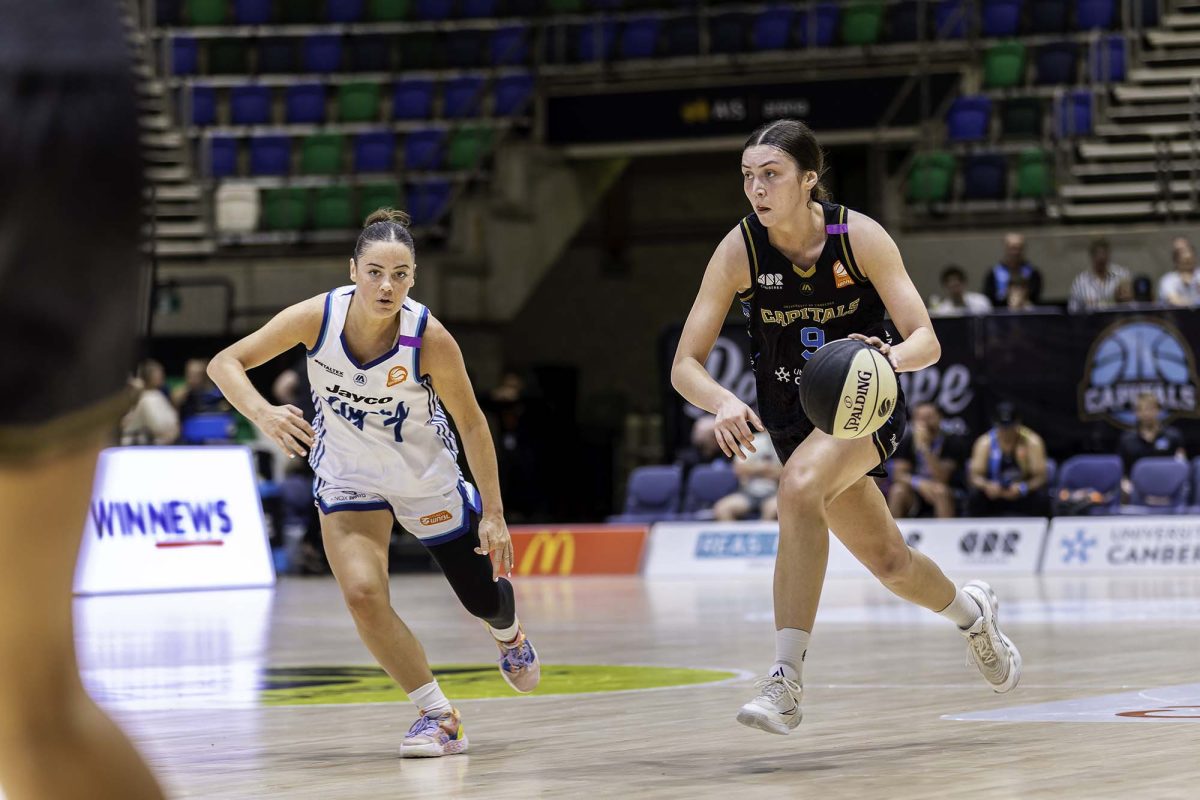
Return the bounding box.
[509,525,647,576]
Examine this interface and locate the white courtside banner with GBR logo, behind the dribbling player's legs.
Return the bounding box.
[646,517,1046,577]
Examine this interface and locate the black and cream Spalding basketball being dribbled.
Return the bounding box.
[800,339,896,439]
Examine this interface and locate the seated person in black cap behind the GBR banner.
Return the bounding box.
[967,402,1049,517]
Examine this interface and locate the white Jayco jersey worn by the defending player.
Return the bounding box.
[308,285,462,498]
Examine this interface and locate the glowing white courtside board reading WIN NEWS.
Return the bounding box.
[74,447,275,595]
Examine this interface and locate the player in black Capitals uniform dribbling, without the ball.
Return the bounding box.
[671,120,1021,734]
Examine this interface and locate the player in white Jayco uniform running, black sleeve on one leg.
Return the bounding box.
[209,209,540,757]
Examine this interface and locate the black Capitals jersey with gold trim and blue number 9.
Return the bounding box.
[738,203,890,431]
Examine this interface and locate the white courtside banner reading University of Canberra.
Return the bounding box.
[1042,515,1200,575]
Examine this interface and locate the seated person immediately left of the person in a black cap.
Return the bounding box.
[888,403,966,519]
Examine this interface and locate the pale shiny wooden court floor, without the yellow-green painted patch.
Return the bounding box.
[70,575,1200,800]
